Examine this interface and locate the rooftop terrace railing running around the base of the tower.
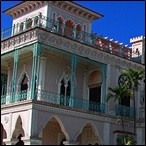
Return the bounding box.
[1,15,141,63]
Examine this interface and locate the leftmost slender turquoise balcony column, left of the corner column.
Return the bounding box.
[11,50,19,102]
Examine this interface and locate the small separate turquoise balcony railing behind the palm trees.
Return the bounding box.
[115,105,134,118]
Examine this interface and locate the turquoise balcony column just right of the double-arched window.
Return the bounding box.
[70,54,77,105]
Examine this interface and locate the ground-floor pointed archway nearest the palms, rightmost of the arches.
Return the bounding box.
[76,123,100,145]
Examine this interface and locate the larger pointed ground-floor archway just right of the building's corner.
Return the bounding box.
[40,118,66,145]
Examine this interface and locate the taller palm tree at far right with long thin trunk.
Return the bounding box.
[122,69,144,134]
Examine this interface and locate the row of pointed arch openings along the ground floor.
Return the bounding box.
[1,116,101,145]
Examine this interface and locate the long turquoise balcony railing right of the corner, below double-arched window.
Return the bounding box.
[38,91,105,113]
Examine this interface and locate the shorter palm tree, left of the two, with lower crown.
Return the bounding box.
[106,83,132,145]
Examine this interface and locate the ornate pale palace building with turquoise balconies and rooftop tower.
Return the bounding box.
[1,1,145,145]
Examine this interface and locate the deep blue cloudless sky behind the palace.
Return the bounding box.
[1,1,145,46]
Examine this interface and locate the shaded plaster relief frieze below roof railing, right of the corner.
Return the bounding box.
[39,31,144,68]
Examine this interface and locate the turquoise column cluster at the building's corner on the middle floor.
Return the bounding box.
[30,43,40,99]
